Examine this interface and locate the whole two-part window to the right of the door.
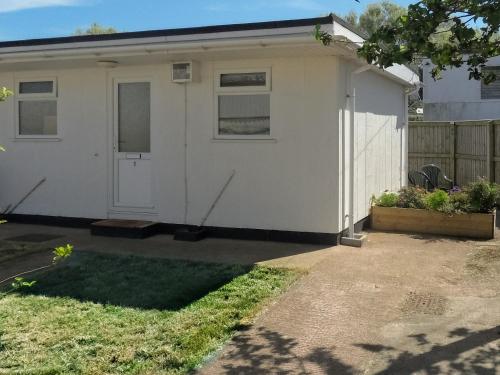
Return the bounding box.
[216,69,271,139]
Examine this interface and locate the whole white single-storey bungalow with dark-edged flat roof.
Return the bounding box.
[0,16,418,243]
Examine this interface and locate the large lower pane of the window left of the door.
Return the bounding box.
[19,100,57,135]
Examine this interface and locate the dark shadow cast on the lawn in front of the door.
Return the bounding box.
[22,253,252,311]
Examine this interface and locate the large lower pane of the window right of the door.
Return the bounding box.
[219,94,271,135]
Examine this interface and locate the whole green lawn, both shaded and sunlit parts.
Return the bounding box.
[0,253,298,375]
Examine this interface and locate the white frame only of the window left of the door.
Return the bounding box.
[14,77,60,140]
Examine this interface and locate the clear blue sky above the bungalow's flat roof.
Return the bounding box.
[0,0,411,40]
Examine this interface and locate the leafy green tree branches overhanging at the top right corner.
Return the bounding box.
[358,0,500,84]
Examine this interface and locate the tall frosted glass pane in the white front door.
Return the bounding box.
[118,82,151,152]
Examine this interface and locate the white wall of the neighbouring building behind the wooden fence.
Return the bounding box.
[423,56,500,121]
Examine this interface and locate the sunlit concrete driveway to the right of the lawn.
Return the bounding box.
[200,233,500,375]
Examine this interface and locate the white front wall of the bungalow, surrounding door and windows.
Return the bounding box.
[0,57,344,233]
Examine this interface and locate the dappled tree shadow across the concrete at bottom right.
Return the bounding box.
[210,326,500,375]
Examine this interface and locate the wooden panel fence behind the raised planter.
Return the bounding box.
[408,120,500,186]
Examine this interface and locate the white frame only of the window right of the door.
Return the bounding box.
[214,68,273,140]
